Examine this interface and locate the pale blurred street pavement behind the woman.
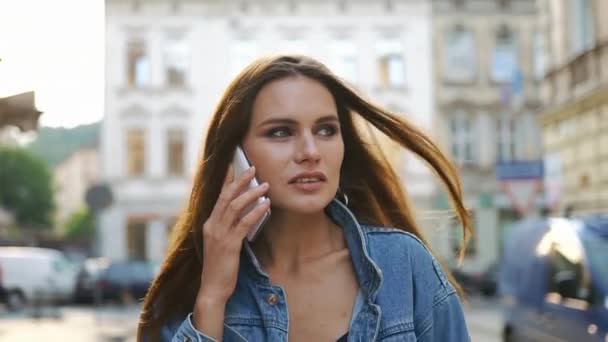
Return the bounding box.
[0,297,501,342]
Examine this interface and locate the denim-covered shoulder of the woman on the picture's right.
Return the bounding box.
[361,225,458,336]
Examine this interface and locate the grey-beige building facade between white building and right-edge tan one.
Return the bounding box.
[433,0,543,272]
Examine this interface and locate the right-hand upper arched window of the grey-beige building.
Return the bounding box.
[490,26,519,83]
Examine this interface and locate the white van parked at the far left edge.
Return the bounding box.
[0,247,76,309]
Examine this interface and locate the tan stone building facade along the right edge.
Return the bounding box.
[538,0,608,212]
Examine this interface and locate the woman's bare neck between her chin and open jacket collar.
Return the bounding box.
[253,209,346,273]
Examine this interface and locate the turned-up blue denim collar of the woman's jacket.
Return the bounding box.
[241,199,382,302]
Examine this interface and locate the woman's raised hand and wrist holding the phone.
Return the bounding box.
[195,166,270,304]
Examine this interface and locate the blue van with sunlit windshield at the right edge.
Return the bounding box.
[499,215,608,341]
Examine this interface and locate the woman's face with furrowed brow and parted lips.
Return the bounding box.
[243,76,344,213]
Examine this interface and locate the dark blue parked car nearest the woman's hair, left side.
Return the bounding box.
[96,260,157,302]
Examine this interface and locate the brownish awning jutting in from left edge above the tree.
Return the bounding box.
[0,91,42,132]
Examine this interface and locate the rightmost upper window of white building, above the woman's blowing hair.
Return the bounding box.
[377,40,405,89]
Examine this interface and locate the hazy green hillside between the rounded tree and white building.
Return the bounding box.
[28,123,100,167]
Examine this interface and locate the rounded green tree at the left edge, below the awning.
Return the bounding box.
[0,146,55,229]
